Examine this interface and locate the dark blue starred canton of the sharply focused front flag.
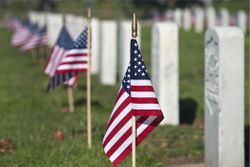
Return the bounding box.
[122,39,149,94]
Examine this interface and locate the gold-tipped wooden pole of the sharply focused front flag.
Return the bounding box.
[132,13,137,167]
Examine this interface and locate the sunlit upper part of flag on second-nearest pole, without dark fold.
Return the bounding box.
[56,26,88,73]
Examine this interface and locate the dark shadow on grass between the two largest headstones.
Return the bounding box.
[179,98,198,125]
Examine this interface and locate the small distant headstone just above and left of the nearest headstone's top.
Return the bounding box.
[194,8,205,33]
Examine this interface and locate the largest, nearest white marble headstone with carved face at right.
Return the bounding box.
[205,27,244,167]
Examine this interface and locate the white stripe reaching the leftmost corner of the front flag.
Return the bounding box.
[103,104,131,142]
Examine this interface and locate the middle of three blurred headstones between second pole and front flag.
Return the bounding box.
[100,20,117,85]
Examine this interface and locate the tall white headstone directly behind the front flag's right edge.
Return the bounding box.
[151,22,179,125]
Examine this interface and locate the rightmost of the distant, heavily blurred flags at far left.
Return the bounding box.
[21,27,48,51]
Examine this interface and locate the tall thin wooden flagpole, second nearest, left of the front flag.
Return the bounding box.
[87,8,92,148]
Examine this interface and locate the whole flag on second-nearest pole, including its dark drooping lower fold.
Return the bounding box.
[48,27,88,90]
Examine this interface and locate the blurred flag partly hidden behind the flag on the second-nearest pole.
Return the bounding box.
[45,26,74,77]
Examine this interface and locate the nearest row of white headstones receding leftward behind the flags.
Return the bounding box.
[27,11,244,167]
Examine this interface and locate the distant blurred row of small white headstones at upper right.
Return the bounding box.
[164,7,250,33]
